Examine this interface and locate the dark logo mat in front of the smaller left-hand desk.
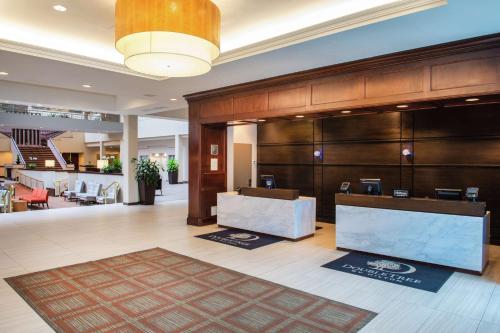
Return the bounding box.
[196,229,283,250]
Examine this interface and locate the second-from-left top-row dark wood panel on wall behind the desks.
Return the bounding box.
[323,112,401,142]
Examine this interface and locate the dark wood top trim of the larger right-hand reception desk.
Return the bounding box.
[335,193,486,217]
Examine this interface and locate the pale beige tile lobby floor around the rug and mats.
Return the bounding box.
[0,192,500,333]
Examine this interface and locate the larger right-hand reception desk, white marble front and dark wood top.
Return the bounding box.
[335,194,490,273]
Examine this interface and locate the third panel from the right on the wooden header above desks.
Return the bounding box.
[311,74,365,105]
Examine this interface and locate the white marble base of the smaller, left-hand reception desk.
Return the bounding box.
[217,192,316,240]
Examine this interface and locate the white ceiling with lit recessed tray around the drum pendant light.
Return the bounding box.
[0,0,500,119]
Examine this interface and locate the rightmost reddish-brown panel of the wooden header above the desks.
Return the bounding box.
[432,57,500,90]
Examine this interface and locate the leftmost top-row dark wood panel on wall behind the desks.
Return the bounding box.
[257,119,314,144]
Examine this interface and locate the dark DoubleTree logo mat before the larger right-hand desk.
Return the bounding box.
[321,252,453,293]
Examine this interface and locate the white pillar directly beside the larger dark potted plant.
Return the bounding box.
[120,116,139,205]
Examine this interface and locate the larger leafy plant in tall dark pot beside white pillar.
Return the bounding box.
[132,158,160,205]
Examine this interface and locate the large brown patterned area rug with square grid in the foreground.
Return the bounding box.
[5,248,375,333]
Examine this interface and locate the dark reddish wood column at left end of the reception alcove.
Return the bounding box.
[187,102,227,226]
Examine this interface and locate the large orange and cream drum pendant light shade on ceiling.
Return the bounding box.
[115,0,220,77]
